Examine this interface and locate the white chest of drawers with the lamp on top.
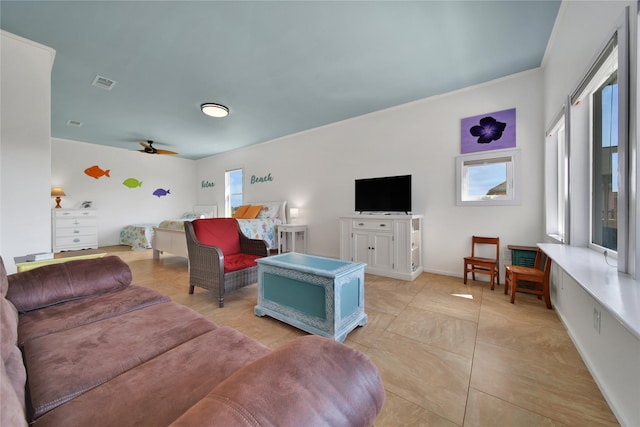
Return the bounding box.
[51,209,98,252]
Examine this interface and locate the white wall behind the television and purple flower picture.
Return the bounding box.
[197,70,544,276]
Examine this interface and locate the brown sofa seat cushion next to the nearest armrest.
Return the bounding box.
[35,326,271,427]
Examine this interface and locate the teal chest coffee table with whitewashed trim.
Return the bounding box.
[254,252,367,341]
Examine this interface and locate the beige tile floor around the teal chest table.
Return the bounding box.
[106,246,618,426]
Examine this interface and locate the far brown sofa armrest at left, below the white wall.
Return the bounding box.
[7,256,132,313]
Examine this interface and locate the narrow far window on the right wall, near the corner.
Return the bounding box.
[545,111,569,243]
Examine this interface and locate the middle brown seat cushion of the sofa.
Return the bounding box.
[24,303,217,419]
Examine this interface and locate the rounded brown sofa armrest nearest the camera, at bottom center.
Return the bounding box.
[172,335,385,427]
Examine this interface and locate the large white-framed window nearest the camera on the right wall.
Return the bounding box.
[569,23,640,274]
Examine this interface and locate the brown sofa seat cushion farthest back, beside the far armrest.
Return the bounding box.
[18,285,170,345]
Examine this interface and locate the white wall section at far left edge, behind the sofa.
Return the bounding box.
[0,31,55,273]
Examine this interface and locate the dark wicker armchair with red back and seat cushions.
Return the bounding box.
[184,218,269,308]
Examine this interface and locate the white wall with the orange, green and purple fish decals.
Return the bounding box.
[49,138,200,246]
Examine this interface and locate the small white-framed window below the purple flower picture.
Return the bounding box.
[456,150,520,206]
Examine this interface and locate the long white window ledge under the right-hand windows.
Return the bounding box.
[538,243,640,339]
